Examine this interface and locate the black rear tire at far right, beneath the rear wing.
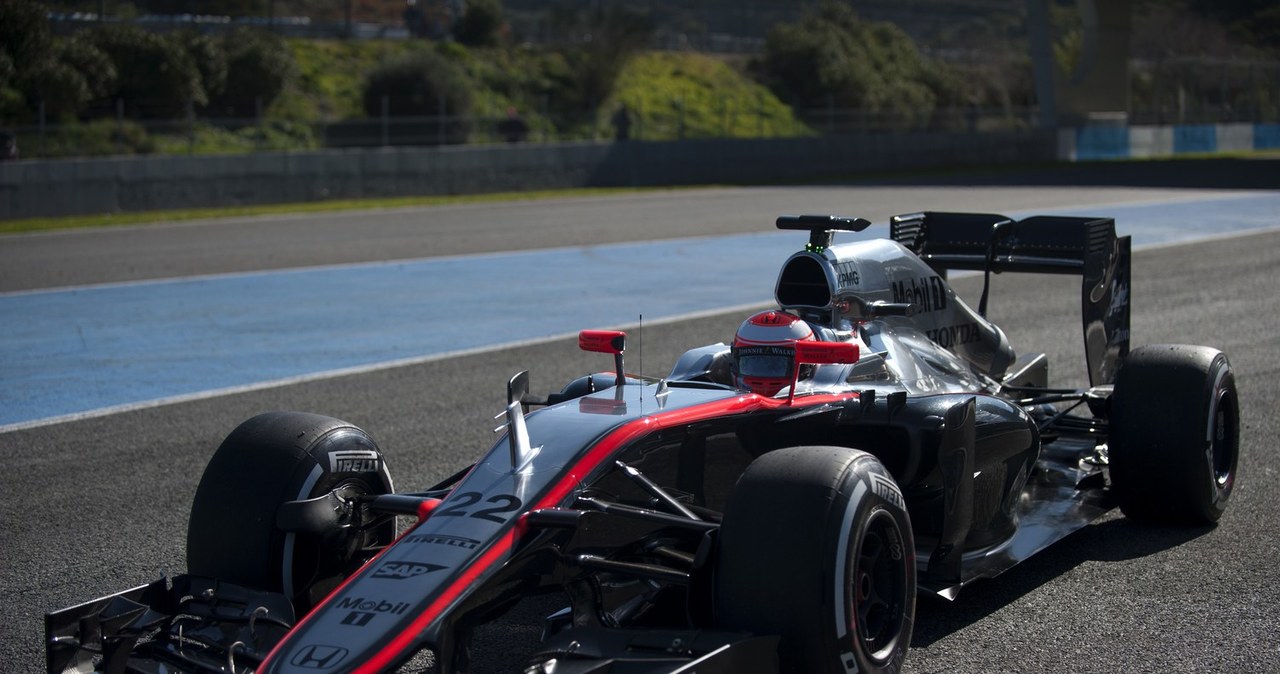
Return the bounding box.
[1107,344,1240,524]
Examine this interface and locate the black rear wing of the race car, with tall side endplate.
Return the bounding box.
[890,211,1130,386]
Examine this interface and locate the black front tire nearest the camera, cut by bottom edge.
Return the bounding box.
[714,446,915,674]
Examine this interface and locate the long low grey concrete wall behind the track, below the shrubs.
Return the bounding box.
[0,132,1056,219]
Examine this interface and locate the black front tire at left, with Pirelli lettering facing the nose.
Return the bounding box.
[187,412,396,615]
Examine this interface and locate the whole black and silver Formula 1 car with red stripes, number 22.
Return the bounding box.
[46,212,1239,674]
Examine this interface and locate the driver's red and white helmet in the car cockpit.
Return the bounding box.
[732,311,817,398]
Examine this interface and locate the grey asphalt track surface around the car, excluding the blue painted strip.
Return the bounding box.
[0,161,1280,673]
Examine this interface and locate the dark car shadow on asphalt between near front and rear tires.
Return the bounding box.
[911,517,1213,648]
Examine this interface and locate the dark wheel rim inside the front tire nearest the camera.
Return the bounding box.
[851,510,908,662]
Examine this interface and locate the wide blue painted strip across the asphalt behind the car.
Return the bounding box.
[0,193,1280,432]
